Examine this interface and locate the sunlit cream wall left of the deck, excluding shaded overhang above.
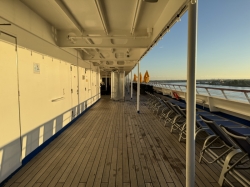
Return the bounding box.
[0,40,99,182]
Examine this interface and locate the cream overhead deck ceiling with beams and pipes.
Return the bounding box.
[21,0,187,75]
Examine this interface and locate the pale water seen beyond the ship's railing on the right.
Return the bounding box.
[155,82,250,103]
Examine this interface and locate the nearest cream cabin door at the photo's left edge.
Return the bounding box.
[0,35,22,183]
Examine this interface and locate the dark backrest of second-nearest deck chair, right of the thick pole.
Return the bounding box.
[199,115,238,149]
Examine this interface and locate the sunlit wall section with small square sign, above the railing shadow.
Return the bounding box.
[18,48,71,135]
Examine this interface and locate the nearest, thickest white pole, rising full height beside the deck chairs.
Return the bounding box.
[186,0,198,187]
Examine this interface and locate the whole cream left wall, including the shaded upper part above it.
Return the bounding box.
[0,0,99,183]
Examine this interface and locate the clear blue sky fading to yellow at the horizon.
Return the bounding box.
[133,0,250,80]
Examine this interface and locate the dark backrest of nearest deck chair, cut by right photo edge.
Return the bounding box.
[221,125,250,156]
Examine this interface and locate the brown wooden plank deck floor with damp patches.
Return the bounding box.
[2,96,223,187]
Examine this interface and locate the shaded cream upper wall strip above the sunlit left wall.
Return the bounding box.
[0,0,77,65]
